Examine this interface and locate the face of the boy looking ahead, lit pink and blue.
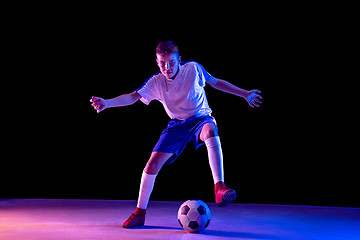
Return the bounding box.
[156,53,181,79]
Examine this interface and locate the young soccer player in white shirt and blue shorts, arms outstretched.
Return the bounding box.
[90,41,261,228]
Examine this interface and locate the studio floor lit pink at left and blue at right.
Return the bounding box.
[0,199,360,240]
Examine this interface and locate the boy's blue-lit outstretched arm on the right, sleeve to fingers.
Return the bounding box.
[206,77,262,107]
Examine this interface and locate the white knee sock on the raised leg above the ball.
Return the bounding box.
[205,136,224,184]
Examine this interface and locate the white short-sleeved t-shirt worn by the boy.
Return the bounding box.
[136,62,212,120]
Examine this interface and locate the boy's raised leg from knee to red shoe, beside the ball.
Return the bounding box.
[200,123,236,207]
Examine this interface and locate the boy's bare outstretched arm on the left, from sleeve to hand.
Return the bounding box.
[90,92,141,113]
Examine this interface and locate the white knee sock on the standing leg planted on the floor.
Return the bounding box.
[137,171,157,209]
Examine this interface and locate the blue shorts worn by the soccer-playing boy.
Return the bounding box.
[153,116,216,164]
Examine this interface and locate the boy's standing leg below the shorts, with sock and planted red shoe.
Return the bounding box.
[123,152,173,228]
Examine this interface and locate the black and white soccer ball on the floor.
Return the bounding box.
[178,200,211,233]
